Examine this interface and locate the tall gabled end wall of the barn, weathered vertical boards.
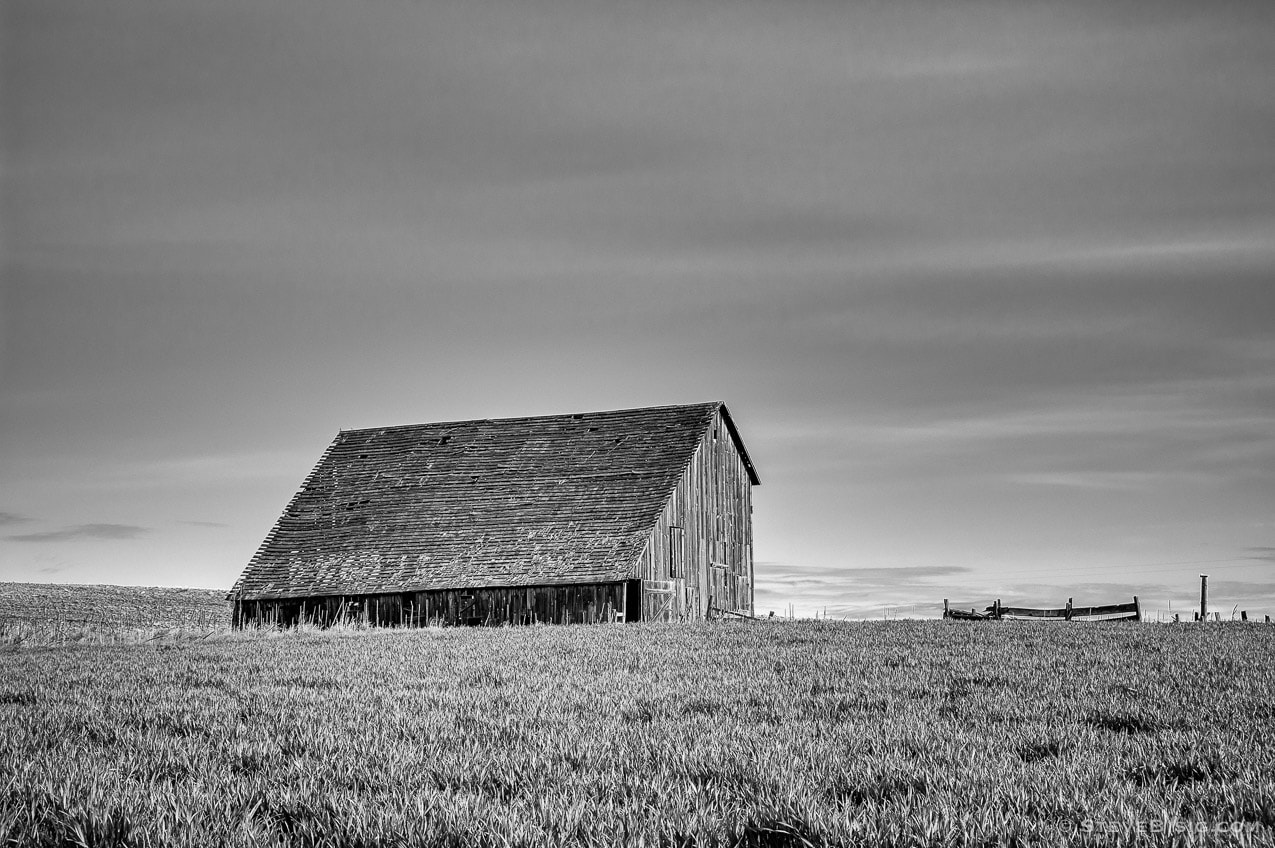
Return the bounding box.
[638,412,754,621]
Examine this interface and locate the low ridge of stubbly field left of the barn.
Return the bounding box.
[0,583,231,630]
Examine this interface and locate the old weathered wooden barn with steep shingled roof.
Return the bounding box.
[231,403,759,626]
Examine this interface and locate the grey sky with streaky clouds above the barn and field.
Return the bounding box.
[0,0,1275,617]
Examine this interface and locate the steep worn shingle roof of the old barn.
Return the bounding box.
[231,402,759,601]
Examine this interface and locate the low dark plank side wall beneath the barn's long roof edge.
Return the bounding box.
[235,580,640,627]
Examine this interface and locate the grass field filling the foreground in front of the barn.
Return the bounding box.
[0,621,1275,845]
